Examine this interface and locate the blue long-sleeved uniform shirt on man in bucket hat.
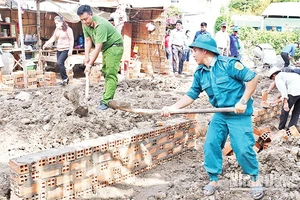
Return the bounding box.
[186,56,256,115]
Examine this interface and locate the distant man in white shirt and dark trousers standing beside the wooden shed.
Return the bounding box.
[170,20,185,75]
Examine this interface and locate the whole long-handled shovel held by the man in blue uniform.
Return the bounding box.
[108,100,234,115]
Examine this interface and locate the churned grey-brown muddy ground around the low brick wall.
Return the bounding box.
[0,63,300,200]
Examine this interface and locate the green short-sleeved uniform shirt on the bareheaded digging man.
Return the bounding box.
[82,16,123,52]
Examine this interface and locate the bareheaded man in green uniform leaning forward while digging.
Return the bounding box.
[77,5,124,110]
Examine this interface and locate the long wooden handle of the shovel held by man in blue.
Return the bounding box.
[126,107,234,114]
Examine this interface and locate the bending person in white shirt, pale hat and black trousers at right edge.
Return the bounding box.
[267,67,300,130]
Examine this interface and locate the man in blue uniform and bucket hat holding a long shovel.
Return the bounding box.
[162,35,263,199]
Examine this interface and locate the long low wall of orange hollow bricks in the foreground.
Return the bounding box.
[9,119,196,200]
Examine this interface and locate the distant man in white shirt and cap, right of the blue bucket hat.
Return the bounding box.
[215,22,230,56]
